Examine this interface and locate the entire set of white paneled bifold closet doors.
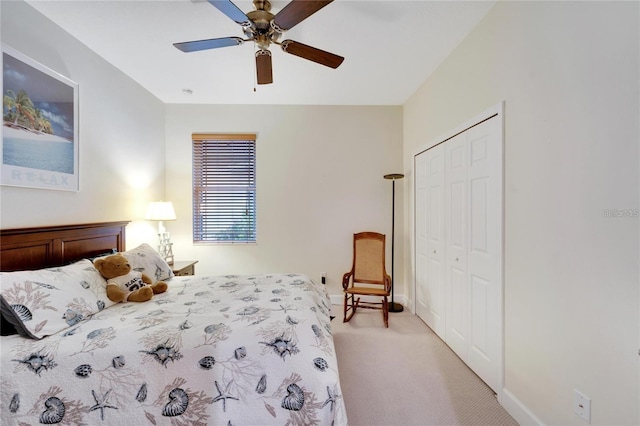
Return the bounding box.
[415,111,503,394]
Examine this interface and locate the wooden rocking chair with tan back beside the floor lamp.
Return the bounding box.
[342,232,391,327]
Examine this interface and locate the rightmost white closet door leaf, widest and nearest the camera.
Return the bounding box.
[465,117,502,390]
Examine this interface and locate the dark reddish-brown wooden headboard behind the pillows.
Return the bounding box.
[0,221,129,272]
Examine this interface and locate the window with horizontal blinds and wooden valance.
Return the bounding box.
[192,133,256,243]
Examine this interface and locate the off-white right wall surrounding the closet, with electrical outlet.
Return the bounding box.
[404,2,640,425]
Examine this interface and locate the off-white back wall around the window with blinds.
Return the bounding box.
[166,105,403,294]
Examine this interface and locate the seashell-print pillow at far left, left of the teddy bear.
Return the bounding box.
[0,259,114,339]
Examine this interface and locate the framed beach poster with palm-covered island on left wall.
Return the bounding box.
[0,45,79,191]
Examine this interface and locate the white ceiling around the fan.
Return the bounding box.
[27,0,495,105]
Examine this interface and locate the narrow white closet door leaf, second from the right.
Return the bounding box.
[443,133,469,361]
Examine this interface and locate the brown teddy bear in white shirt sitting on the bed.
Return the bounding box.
[93,253,168,303]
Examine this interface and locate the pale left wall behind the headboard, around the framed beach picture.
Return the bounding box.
[0,1,165,247]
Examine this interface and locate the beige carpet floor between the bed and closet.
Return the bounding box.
[331,306,517,426]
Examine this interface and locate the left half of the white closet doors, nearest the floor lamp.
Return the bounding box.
[415,146,445,339]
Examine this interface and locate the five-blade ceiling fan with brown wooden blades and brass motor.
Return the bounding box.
[173,0,344,84]
